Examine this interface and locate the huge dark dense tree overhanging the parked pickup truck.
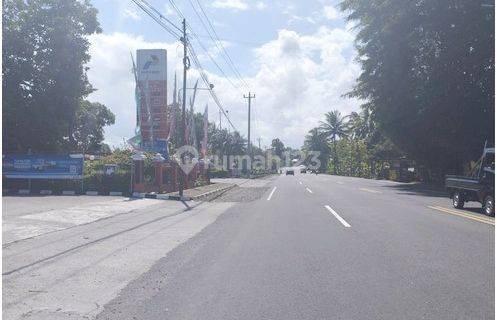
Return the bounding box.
[341,0,495,173]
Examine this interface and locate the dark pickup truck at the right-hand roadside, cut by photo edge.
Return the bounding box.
[445,147,495,216]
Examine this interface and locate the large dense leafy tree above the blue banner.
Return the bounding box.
[2,0,100,152]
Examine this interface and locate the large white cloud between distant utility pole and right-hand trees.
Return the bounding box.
[248,27,360,146]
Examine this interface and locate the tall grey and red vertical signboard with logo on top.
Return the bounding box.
[136,49,169,157]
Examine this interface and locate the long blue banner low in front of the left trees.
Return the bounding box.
[2,154,83,179]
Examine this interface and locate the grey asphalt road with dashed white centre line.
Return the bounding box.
[97,174,495,320]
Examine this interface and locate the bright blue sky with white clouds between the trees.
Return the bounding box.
[88,0,360,148]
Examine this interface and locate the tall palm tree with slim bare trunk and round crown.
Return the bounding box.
[319,110,349,174]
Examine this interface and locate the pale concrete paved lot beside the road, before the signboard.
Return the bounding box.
[2,197,233,319]
